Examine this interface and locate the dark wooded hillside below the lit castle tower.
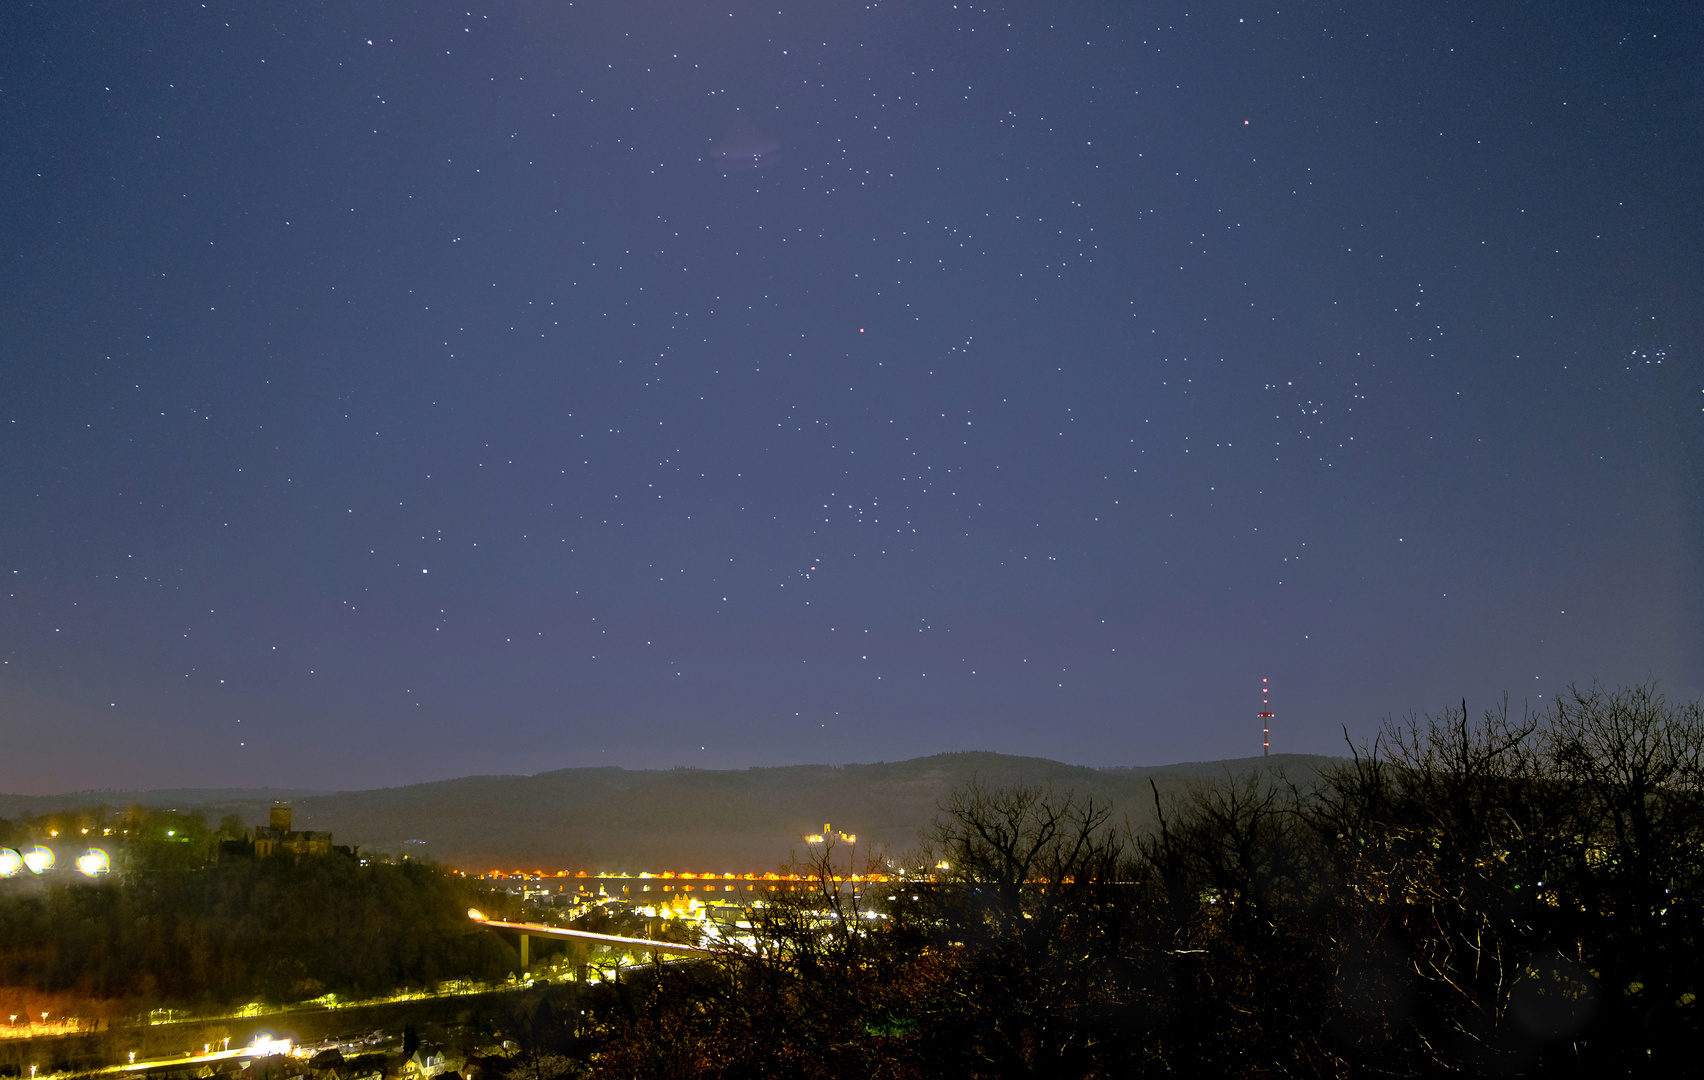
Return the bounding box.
[0,831,515,1017]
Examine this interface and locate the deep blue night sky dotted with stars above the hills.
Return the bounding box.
[0,0,1704,792]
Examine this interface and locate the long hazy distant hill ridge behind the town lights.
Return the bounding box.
[0,753,1336,872]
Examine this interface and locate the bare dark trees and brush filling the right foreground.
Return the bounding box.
[552,686,1704,1078]
